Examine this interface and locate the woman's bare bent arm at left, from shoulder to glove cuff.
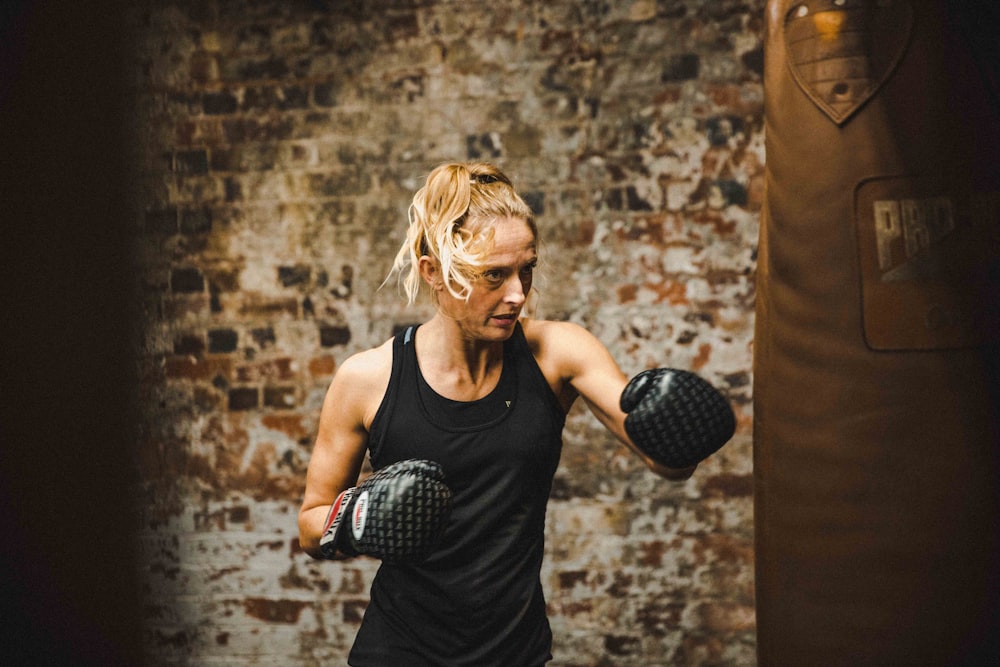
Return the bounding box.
[299,345,392,558]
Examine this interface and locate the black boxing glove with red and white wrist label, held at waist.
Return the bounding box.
[319,459,451,562]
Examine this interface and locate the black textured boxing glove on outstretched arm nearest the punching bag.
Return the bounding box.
[620,368,736,469]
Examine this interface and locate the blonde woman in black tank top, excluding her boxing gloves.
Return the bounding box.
[299,163,694,667]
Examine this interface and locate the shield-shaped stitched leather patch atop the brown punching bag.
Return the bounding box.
[784,0,913,125]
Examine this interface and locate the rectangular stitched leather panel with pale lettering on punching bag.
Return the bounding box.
[854,176,1000,350]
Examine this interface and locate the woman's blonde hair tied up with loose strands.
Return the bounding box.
[386,162,538,304]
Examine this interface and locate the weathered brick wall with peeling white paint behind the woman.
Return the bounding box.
[128,0,764,666]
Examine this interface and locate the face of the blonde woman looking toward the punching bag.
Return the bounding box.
[438,218,538,341]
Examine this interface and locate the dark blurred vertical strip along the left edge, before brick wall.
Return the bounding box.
[0,0,141,666]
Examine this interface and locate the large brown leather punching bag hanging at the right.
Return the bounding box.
[754,0,1000,667]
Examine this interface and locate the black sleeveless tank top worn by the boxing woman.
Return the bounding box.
[349,324,566,667]
